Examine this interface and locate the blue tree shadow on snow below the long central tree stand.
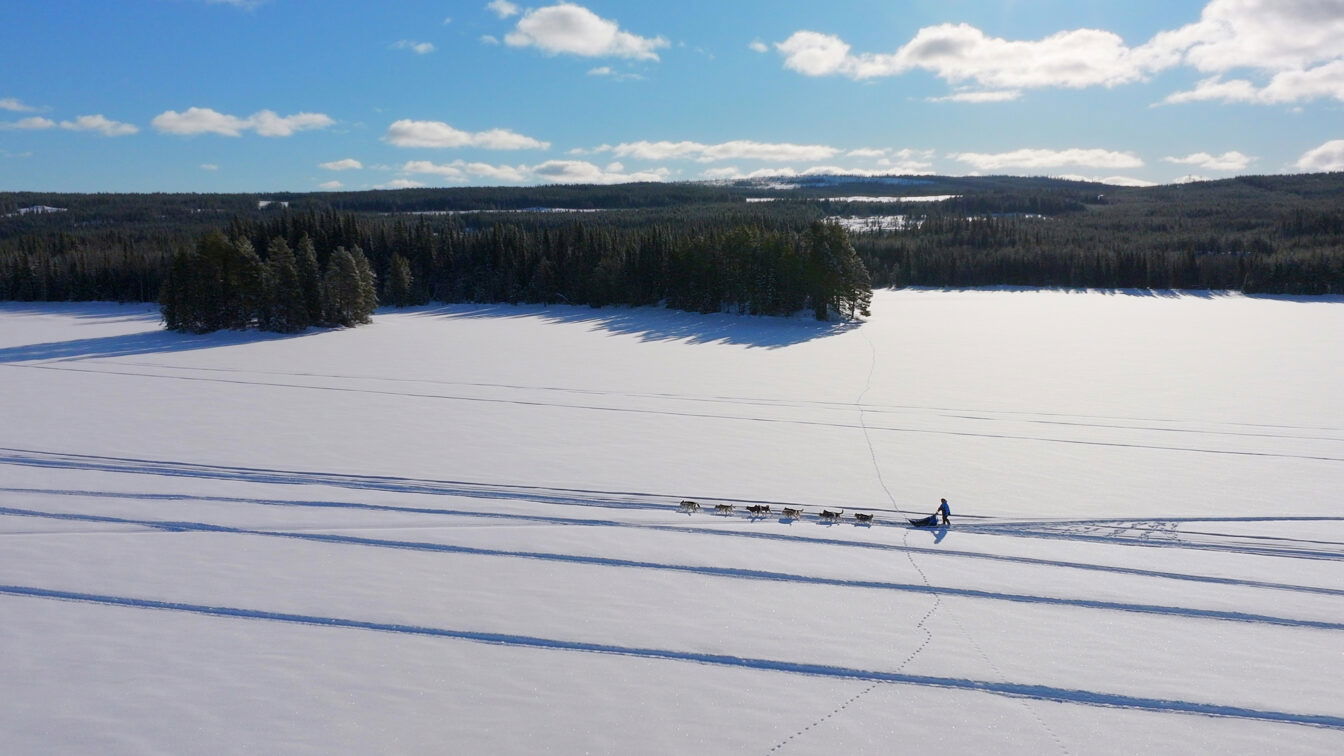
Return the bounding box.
[413,304,860,348]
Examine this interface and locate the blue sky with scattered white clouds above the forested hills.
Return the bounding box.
[0,0,1344,192]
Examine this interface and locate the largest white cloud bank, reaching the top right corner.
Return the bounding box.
[775,0,1344,105]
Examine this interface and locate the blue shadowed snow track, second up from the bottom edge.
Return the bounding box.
[0,507,1344,631]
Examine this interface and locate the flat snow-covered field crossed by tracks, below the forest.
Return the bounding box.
[0,291,1344,755]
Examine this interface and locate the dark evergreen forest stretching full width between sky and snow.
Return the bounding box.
[0,174,1344,332]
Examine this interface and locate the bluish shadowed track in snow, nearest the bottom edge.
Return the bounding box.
[0,585,1344,729]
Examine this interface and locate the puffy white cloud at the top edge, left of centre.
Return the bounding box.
[504,3,668,61]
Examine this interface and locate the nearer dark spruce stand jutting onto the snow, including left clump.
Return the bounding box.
[159,215,872,332]
